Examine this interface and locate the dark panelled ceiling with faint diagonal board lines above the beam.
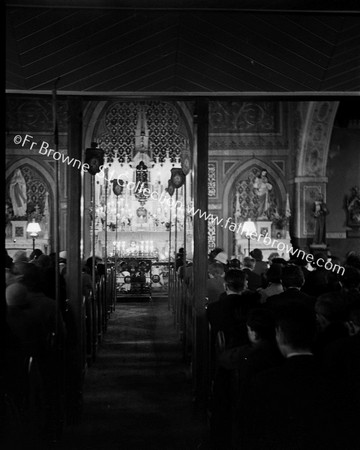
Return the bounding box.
[6,0,360,94]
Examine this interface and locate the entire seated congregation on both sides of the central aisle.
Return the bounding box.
[3,248,360,450]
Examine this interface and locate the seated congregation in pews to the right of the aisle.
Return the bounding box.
[206,248,360,450]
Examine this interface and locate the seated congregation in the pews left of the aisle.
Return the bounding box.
[2,249,102,448]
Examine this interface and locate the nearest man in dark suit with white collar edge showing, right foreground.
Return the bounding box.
[239,303,356,450]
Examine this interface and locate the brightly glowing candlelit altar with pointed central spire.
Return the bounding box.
[90,107,190,261]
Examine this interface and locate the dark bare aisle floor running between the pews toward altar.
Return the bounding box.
[54,298,208,450]
